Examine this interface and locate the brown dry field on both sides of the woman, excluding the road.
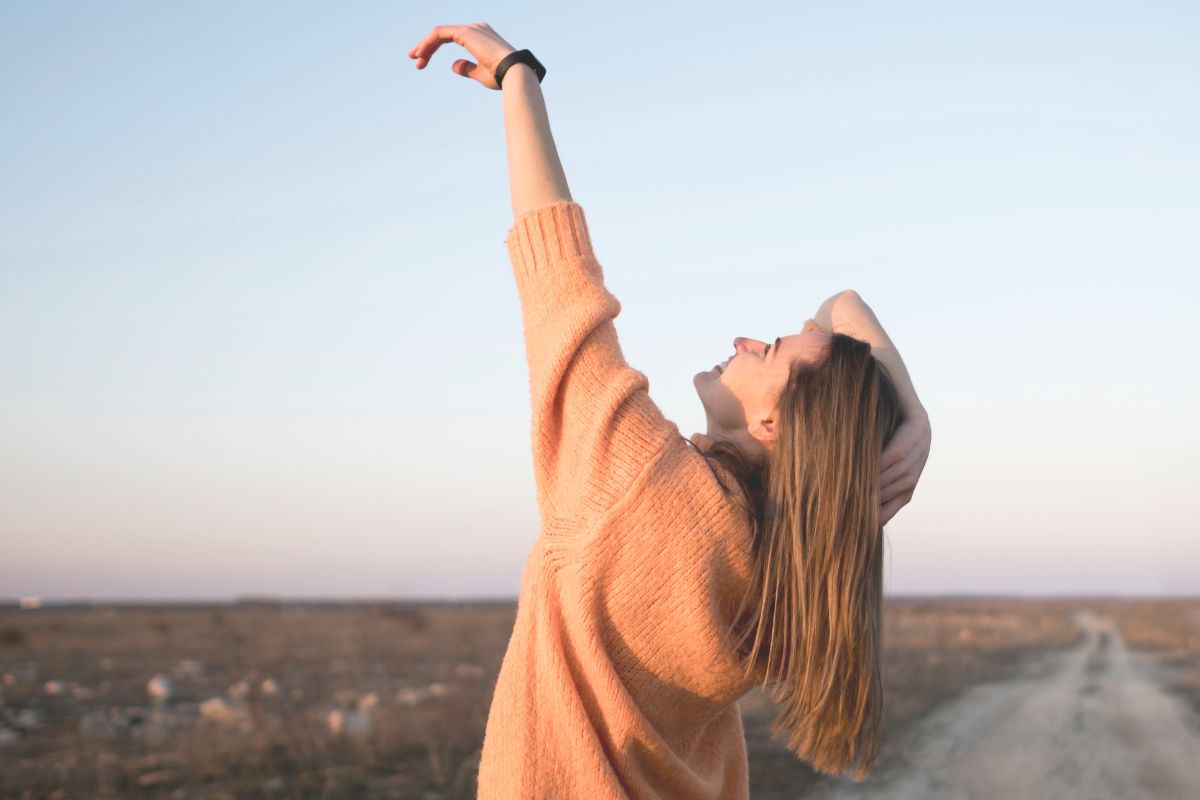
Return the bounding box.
[0,599,1200,800]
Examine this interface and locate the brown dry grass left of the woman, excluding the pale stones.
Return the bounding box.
[0,603,515,799]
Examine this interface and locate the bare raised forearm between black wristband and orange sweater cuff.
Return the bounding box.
[502,64,572,219]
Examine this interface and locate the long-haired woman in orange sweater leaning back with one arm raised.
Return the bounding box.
[409,24,930,800]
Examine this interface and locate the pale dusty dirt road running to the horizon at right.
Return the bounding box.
[810,612,1200,800]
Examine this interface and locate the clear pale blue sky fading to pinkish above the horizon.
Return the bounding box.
[0,1,1200,599]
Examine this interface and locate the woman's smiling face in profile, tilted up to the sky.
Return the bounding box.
[691,331,830,445]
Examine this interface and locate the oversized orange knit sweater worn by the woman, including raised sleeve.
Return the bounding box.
[478,200,754,800]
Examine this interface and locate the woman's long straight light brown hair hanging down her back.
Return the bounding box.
[704,333,901,782]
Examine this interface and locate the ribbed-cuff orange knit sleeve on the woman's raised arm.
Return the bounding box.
[504,200,679,539]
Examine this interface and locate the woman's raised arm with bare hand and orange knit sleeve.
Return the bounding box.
[409,24,685,545]
